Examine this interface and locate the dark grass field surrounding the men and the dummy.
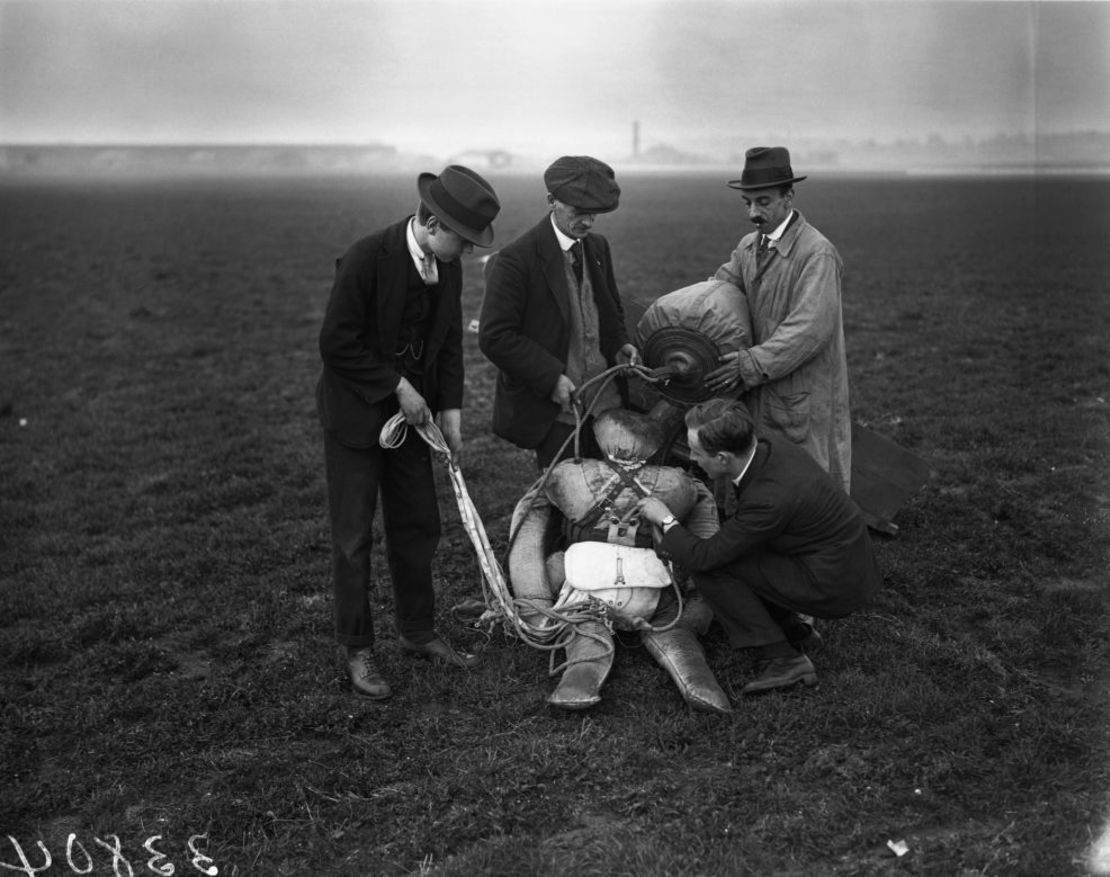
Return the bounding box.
[0,168,1110,877]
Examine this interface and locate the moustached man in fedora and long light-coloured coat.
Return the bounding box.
[706,147,851,491]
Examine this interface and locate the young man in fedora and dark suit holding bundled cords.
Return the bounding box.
[316,165,501,699]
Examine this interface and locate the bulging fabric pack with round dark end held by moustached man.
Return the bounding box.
[636,280,751,403]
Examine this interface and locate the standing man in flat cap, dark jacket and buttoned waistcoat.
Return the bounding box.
[478,155,638,470]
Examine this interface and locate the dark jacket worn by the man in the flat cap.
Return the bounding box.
[478,215,628,447]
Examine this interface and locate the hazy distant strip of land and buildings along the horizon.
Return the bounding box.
[0,137,1110,179]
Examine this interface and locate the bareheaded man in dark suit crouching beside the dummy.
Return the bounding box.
[639,399,881,694]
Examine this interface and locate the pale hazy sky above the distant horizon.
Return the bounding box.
[0,0,1110,154]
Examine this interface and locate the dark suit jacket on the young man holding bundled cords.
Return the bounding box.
[316,219,463,447]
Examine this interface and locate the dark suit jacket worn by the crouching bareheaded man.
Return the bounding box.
[660,437,881,617]
